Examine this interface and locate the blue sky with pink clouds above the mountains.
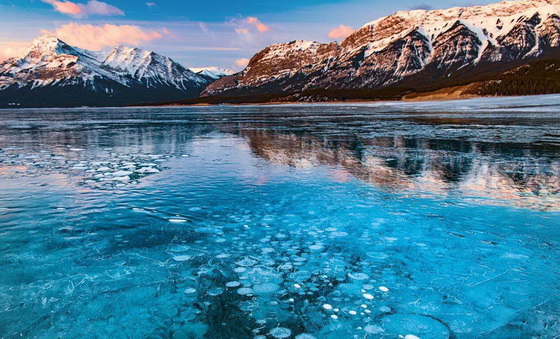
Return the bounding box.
[0,0,496,71]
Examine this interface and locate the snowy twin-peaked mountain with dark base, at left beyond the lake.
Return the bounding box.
[0,35,211,106]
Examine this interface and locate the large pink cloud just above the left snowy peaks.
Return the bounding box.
[42,23,167,50]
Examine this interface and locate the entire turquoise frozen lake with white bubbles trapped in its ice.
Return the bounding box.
[0,96,560,339]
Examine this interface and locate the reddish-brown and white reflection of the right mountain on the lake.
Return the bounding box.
[239,129,560,210]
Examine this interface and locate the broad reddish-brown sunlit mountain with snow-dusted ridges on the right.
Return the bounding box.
[203,0,560,96]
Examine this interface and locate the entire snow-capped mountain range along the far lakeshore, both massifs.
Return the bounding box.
[0,0,560,107]
